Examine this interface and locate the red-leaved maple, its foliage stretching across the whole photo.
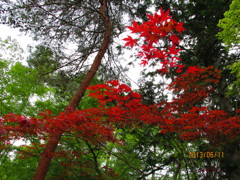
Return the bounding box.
[0,5,240,178]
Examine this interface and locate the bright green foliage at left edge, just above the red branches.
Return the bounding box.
[0,62,49,114]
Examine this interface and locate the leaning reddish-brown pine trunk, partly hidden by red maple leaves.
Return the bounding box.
[33,0,112,180]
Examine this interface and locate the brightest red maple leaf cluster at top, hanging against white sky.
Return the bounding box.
[123,8,185,73]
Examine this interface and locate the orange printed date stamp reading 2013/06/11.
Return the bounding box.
[188,152,224,158]
